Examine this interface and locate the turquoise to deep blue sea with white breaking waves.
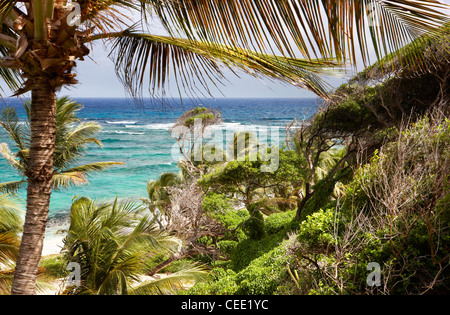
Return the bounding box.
[0,98,320,253]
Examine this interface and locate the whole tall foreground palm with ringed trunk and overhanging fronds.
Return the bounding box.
[0,0,447,294]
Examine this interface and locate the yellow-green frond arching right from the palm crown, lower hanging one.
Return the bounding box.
[91,30,337,96]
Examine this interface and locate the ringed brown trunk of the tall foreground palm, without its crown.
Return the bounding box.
[11,78,56,295]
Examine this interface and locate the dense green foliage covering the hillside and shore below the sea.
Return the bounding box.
[0,24,450,295]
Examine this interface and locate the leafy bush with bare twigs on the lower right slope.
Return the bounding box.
[289,115,450,294]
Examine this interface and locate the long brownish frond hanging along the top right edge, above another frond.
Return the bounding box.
[149,0,449,63]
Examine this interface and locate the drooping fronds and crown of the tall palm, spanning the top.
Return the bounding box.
[0,0,448,100]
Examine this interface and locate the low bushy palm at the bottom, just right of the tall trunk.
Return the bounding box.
[63,197,207,295]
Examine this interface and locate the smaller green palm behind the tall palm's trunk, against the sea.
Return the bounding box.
[0,97,123,193]
